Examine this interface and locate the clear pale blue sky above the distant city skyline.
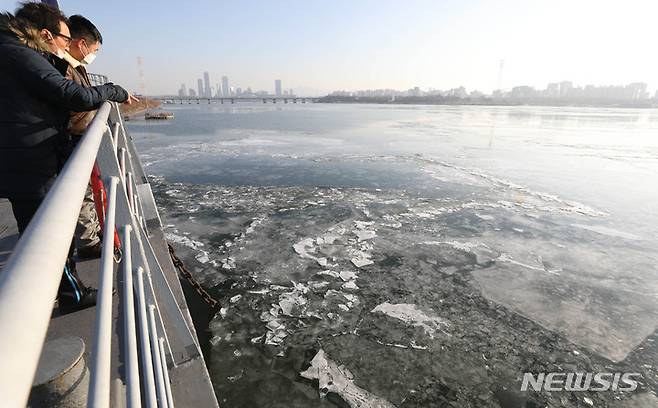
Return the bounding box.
[0,0,658,94]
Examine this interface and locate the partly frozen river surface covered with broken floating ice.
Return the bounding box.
[127,103,658,407]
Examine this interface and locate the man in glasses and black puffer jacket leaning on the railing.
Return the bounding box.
[0,3,136,312]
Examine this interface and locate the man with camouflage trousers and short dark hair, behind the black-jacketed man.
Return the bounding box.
[64,15,103,259]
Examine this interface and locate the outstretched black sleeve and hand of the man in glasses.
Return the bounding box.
[8,47,128,112]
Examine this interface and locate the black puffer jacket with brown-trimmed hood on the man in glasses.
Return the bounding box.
[0,14,128,198]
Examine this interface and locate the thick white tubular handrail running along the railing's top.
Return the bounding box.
[0,102,111,407]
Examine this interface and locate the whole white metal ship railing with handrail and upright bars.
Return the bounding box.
[0,102,201,407]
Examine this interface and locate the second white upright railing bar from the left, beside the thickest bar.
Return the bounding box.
[121,225,142,408]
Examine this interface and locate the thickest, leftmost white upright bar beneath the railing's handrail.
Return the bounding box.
[87,177,119,407]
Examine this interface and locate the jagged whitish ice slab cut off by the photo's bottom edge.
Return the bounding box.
[300,349,395,408]
